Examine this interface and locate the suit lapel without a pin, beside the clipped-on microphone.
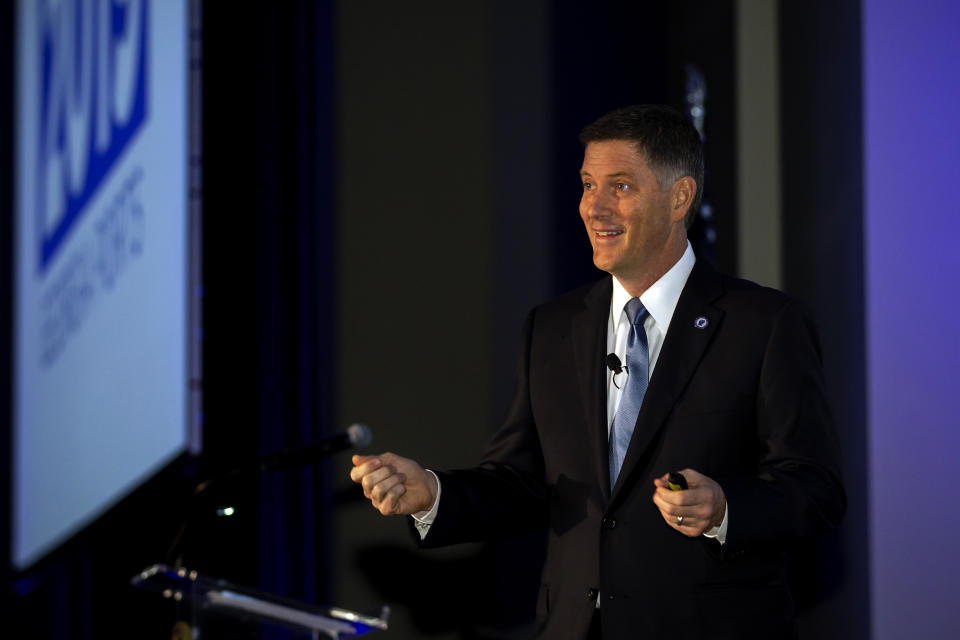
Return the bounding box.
[571,277,613,498]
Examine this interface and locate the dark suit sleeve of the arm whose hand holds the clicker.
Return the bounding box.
[721,301,846,552]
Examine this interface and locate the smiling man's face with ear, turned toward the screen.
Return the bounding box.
[580,140,686,282]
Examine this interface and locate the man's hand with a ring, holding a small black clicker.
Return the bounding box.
[653,469,727,538]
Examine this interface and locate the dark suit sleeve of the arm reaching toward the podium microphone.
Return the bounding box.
[411,310,547,548]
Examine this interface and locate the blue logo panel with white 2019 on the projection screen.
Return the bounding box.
[36,0,149,274]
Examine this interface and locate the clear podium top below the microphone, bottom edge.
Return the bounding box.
[130,564,390,640]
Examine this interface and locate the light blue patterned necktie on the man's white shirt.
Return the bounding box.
[610,298,650,490]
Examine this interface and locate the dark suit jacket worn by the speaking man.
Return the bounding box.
[417,261,846,640]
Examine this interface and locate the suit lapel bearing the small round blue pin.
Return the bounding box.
[612,260,723,499]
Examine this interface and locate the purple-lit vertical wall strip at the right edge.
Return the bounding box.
[862,0,960,640]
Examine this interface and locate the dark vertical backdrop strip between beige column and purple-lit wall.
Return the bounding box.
[779,0,870,640]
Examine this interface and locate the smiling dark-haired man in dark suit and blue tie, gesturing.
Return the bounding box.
[351,105,846,639]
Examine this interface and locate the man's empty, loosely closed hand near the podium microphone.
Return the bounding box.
[350,453,438,516]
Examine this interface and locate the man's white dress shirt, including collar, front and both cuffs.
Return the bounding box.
[413,241,729,544]
